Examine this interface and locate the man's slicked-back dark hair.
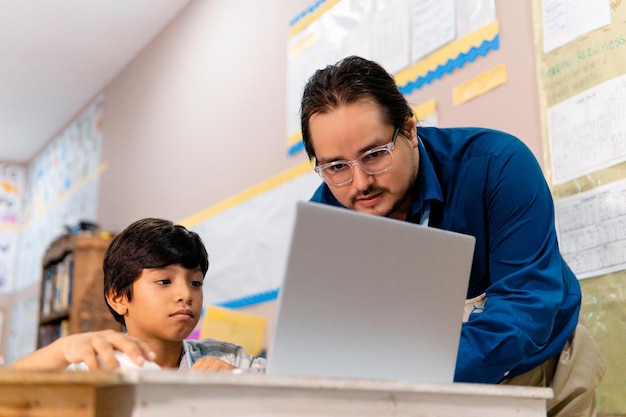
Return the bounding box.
[300,56,413,159]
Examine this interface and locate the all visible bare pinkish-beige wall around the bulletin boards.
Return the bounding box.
[98,0,543,352]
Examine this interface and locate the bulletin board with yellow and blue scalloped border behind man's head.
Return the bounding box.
[287,0,502,156]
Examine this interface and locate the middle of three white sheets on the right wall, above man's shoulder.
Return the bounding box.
[547,75,626,184]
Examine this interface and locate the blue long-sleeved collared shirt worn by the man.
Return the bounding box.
[311,127,581,383]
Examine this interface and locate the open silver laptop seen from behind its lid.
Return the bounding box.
[266,202,475,383]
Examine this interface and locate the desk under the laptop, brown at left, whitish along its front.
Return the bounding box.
[0,371,552,417]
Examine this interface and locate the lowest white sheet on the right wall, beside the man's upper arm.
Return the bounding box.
[555,180,626,279]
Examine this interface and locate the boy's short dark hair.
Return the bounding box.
[103,218,209,325]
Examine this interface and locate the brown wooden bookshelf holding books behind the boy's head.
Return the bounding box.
[37,233,121,348]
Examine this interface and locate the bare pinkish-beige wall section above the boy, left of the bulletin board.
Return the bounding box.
[98,0,311,231]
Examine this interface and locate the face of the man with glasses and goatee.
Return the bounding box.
[309,100,419,220]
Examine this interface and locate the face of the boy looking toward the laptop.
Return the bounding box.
[116,265,204,341]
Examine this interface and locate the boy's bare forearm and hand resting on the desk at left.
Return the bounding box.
[11,330,156,370]
